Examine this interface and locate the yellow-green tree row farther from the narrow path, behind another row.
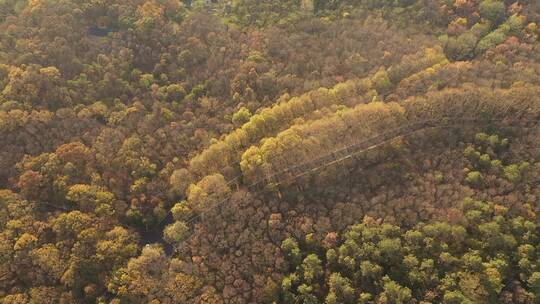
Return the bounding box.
[186,48,446,189]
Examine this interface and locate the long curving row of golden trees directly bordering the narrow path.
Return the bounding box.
[236,86,540,184]
